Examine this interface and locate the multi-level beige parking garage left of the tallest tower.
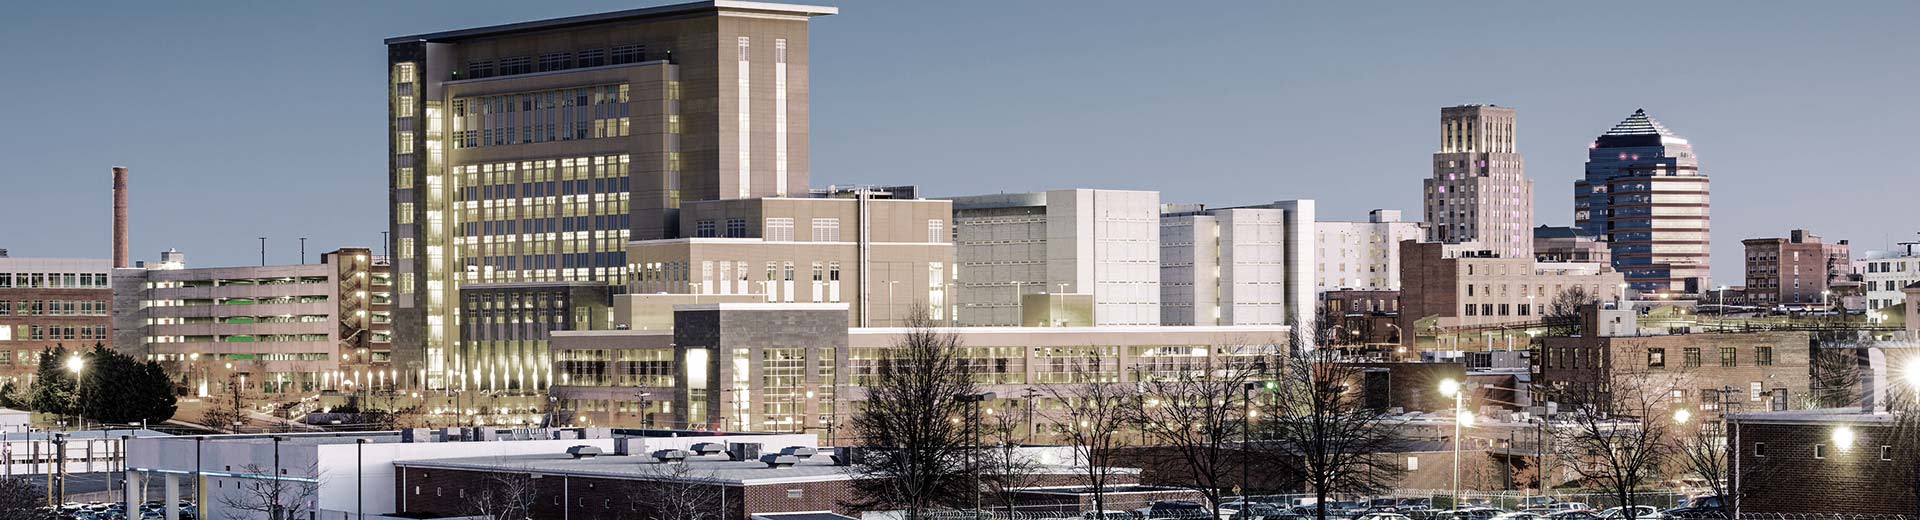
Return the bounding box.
[113,248,397,395]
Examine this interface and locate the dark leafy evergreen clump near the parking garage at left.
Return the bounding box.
[79,343,177,424]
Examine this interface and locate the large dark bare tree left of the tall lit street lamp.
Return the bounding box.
[1254,326,1405,520]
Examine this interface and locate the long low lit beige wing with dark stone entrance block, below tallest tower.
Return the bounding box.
[553,303,1288,437]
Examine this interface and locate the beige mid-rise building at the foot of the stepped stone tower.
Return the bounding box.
[1400,242,1624,340]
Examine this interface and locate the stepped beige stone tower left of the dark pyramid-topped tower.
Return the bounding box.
[1425,106,1534,259]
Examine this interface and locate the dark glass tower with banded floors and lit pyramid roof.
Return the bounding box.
[1572,109,1711,294]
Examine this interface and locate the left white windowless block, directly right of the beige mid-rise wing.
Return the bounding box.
[948,190,1160,326]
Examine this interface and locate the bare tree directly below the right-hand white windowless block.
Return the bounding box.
[1127,357,1256,518]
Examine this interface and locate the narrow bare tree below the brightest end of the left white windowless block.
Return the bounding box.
[1041,347,1135,514]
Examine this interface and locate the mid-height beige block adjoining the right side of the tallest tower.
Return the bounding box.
[628,198,954,326]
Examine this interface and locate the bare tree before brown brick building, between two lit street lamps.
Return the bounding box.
[1549,364,1686,520]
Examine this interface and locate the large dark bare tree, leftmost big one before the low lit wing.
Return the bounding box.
[847,311,979,520]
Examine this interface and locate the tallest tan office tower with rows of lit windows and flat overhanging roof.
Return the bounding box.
[386,0,837,390]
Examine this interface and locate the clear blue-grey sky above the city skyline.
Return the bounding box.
[0,0,1920,284]
